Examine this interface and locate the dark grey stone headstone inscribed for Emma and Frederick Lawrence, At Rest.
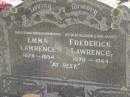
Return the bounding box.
[1,0,129,97]
